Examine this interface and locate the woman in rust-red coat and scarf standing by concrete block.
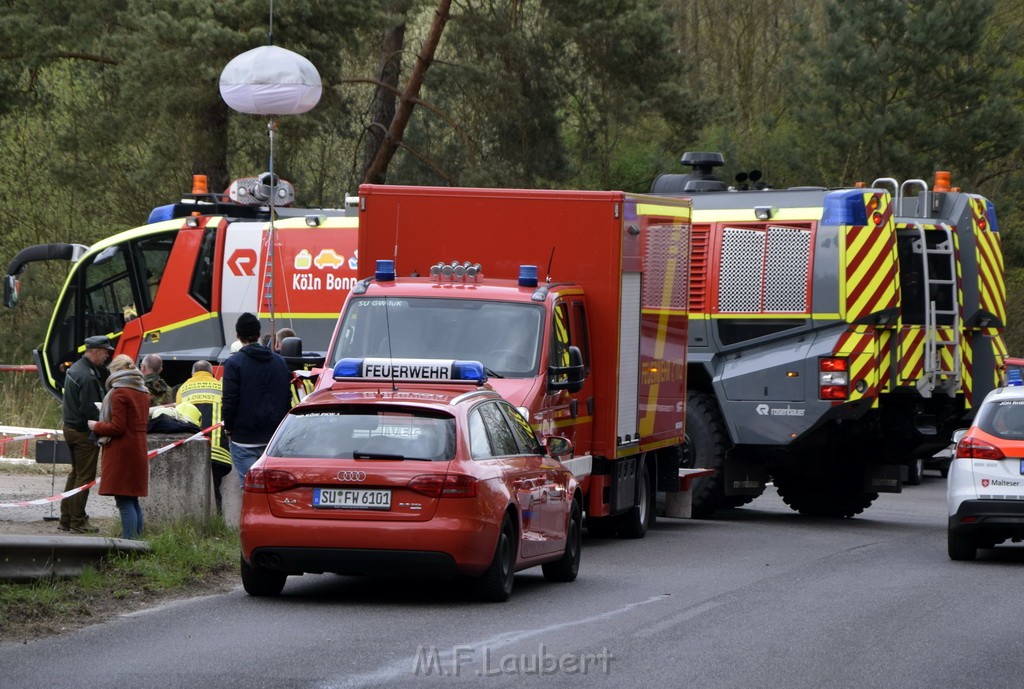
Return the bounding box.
[89,354,150,539]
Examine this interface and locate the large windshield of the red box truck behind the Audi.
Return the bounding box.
[331,297,544,378]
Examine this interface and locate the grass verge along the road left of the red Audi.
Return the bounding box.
[0,518,240,642]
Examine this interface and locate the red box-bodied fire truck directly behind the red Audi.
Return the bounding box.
[321,185,690,537]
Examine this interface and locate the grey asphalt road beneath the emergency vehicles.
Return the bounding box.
[0,476,1024,689]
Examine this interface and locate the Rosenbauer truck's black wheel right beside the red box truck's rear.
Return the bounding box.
[681,392,733,518]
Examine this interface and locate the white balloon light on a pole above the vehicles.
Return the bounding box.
[220,45,323,116]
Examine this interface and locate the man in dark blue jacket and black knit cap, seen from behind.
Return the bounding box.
[221,313,292,485]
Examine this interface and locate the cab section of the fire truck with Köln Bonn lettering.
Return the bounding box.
[4,173,358,397]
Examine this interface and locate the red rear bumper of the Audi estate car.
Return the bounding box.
[241,513,499,576]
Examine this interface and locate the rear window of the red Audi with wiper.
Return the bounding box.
[267,405,456,461]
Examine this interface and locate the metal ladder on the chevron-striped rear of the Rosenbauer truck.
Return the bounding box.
[907,224,963,397]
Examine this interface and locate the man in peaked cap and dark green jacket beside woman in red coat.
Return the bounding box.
[57,335,114,533]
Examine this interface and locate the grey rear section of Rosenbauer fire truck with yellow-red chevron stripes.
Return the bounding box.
[651,153,1007,517]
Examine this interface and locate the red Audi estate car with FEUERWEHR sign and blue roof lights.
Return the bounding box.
[235,359,583,601]
